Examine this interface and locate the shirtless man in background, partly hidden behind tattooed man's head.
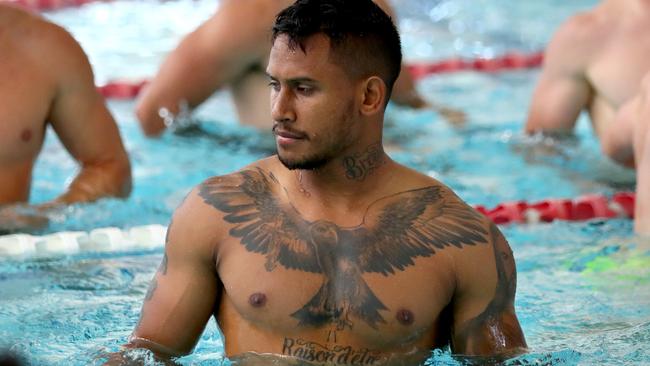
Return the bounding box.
[136,0,465,136]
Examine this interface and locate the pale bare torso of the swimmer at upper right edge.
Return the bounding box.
[586,0,650,135]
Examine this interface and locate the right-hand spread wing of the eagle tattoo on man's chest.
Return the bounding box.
[341,186,488,275]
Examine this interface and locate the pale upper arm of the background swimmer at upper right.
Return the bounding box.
[526,15,593,133]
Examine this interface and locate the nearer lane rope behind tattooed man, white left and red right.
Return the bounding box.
[0,192,634,258]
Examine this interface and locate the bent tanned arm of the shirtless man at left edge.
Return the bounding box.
[48,27,131,204]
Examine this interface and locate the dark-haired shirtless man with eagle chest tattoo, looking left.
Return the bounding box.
[117,0,526,365]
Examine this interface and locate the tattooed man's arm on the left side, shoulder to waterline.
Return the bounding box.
[128,192,220,356]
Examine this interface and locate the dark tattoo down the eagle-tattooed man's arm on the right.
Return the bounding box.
[454,224,526,354]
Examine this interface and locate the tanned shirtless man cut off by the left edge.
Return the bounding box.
[0,3,131,230]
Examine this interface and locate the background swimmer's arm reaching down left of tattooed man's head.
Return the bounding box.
[136,0,275,136]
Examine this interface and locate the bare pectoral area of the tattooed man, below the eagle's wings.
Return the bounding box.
[219,244,454,348]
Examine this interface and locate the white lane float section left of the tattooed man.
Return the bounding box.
[0,225,167,258]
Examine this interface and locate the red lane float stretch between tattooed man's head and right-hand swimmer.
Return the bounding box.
[407,52,544,79]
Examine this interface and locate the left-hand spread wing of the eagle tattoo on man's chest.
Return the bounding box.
[199,168,321,273]
